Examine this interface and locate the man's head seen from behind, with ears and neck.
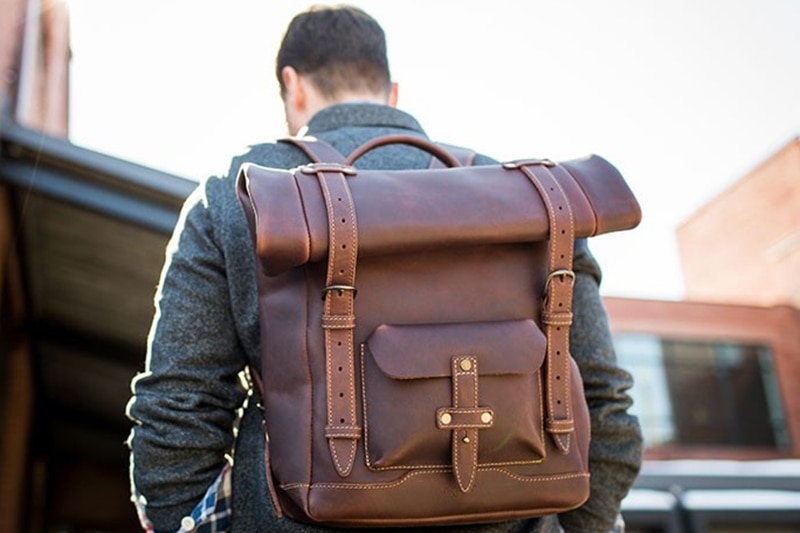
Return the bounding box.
[275,5,397,135]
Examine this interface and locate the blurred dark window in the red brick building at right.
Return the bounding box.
[614,334,789,449]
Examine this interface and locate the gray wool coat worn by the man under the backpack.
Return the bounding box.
[128,103,642,533]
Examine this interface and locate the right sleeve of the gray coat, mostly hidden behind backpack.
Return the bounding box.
[559,240,642,533]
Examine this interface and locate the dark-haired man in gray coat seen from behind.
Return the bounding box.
[129,6,641,533]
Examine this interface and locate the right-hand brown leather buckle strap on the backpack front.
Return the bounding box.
[520,160,575,453]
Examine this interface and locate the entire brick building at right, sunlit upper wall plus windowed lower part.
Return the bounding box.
[606,138,800,459]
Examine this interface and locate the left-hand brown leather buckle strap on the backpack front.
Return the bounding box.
[312,168,361,477]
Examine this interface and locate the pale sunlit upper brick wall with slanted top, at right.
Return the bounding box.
[677,137,800,308]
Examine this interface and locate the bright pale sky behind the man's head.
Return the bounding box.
[69,0,800,299]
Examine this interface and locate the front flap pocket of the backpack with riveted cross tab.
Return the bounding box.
[361,319,546,470]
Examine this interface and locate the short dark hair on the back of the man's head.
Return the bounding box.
[275,5,391,98]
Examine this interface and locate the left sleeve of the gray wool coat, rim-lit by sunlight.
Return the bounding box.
[128,181,246,533]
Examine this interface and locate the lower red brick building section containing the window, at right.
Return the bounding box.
[605,298,800,459]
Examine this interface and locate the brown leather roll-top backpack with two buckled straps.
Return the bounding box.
[238,136,640,527]
